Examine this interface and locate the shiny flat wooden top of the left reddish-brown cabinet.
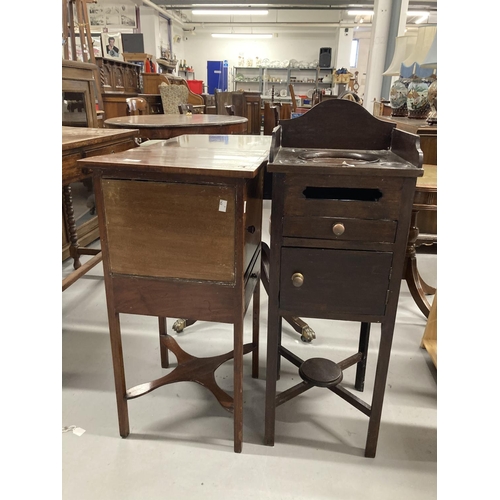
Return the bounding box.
[78,134,271,178]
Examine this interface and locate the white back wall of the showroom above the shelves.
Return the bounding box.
[85,0,370,100]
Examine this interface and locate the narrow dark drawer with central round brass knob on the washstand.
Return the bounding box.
[283,217,397,243]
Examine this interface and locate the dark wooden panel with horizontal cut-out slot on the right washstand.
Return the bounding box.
[284,175,403,220]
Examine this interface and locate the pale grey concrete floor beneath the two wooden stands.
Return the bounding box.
[62,202,437,500]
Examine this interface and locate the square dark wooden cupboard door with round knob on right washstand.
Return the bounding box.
[280,247,393,318]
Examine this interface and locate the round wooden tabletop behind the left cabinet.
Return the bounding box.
[104,114,248,139]
